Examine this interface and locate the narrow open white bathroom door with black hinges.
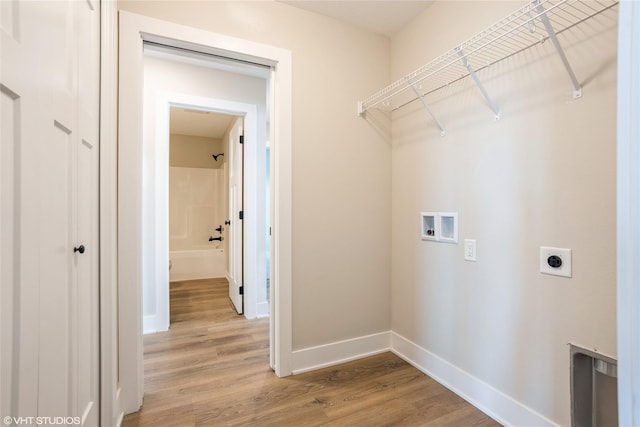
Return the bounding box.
[227,117,244,314]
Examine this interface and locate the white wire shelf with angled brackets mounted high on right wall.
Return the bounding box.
[358,0,618,116]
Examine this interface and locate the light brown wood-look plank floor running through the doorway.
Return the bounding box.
[123,279,499,427]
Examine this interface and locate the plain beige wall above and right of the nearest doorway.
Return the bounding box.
[119,1,391,350]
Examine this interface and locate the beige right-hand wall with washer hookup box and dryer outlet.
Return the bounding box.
[391,1,616,425]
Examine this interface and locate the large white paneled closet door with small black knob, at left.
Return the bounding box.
[0,0,100,426]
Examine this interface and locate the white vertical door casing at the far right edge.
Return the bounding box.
[617,1,640,425]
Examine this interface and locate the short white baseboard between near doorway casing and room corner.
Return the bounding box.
[291,332,390,375]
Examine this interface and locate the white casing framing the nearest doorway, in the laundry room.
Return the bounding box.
[117,11,292,413]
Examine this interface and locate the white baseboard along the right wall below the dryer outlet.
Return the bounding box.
[390,332,557,427]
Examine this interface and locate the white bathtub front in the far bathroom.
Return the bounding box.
[169,246,227,282]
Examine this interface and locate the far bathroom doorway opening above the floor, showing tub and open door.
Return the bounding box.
[168,106,244,314]
